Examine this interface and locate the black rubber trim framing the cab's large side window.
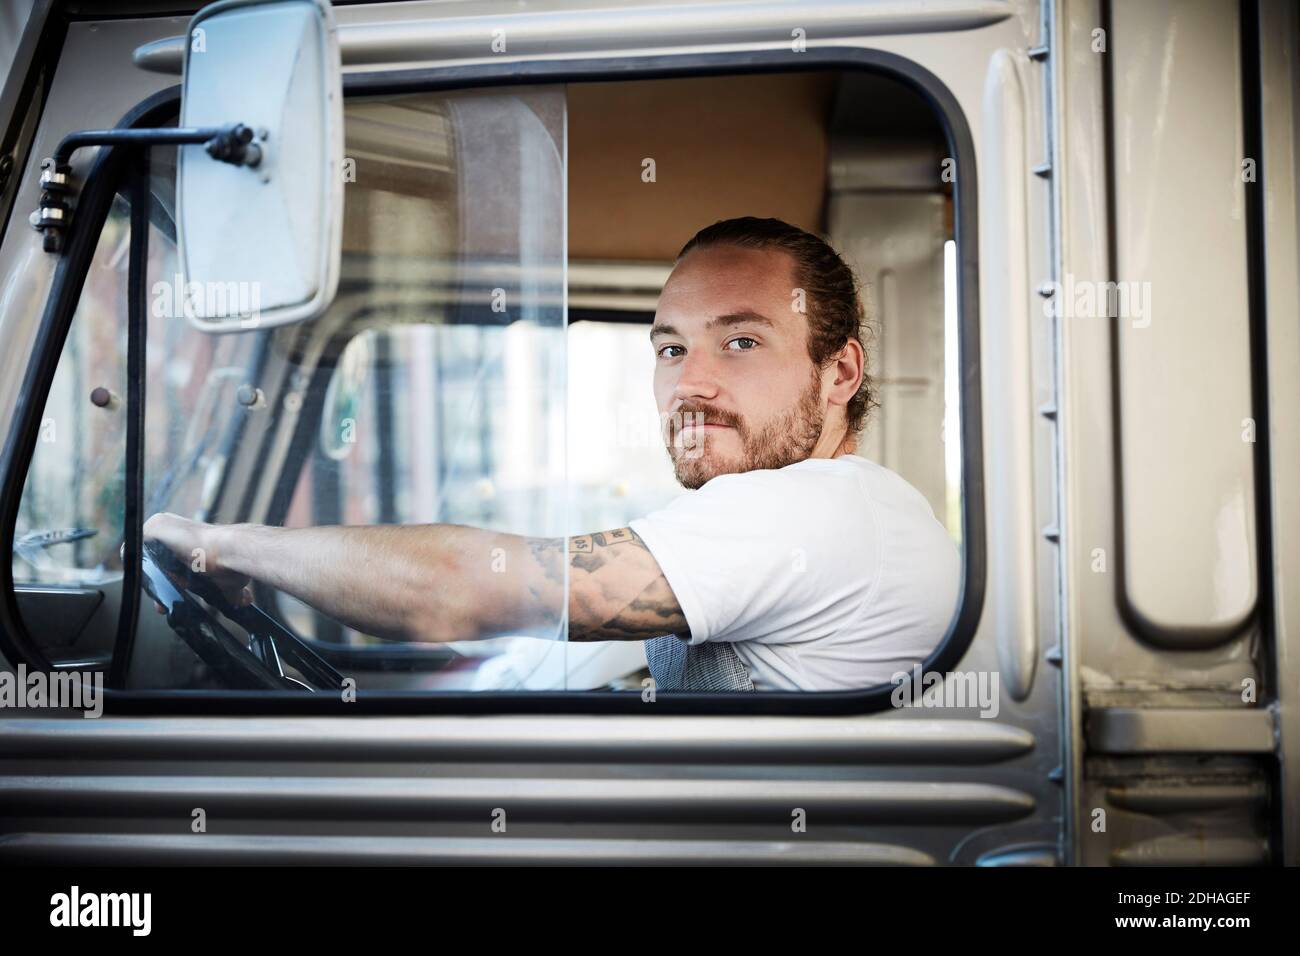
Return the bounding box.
[0,47,987,717]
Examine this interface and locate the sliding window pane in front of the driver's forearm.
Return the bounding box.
[131,88,567,689]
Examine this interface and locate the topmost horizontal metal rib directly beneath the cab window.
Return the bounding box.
[0,715,1034,765]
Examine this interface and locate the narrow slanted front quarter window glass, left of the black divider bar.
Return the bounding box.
[13,183,195,669]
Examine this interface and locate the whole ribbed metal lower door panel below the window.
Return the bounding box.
[0,717,1040,865]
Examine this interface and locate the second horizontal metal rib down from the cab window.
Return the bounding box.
[0,775,1034,825]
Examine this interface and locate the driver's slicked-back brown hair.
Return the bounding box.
[677,216,876,436]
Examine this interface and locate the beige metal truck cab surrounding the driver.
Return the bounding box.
[0,0,1300,866]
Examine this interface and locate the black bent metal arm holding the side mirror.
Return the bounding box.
[30,122,265,252]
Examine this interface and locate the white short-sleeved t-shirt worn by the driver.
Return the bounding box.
[631,455,962,691]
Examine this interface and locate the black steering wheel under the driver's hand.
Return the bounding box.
[140,541,343,691]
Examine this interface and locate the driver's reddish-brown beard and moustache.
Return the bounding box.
[664,365,826,489]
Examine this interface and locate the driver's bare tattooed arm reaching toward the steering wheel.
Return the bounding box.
[144,514,688,641]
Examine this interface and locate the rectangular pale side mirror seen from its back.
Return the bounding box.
[176,0,343,332]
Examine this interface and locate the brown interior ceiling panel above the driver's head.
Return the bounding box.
[568,73,836,261]
